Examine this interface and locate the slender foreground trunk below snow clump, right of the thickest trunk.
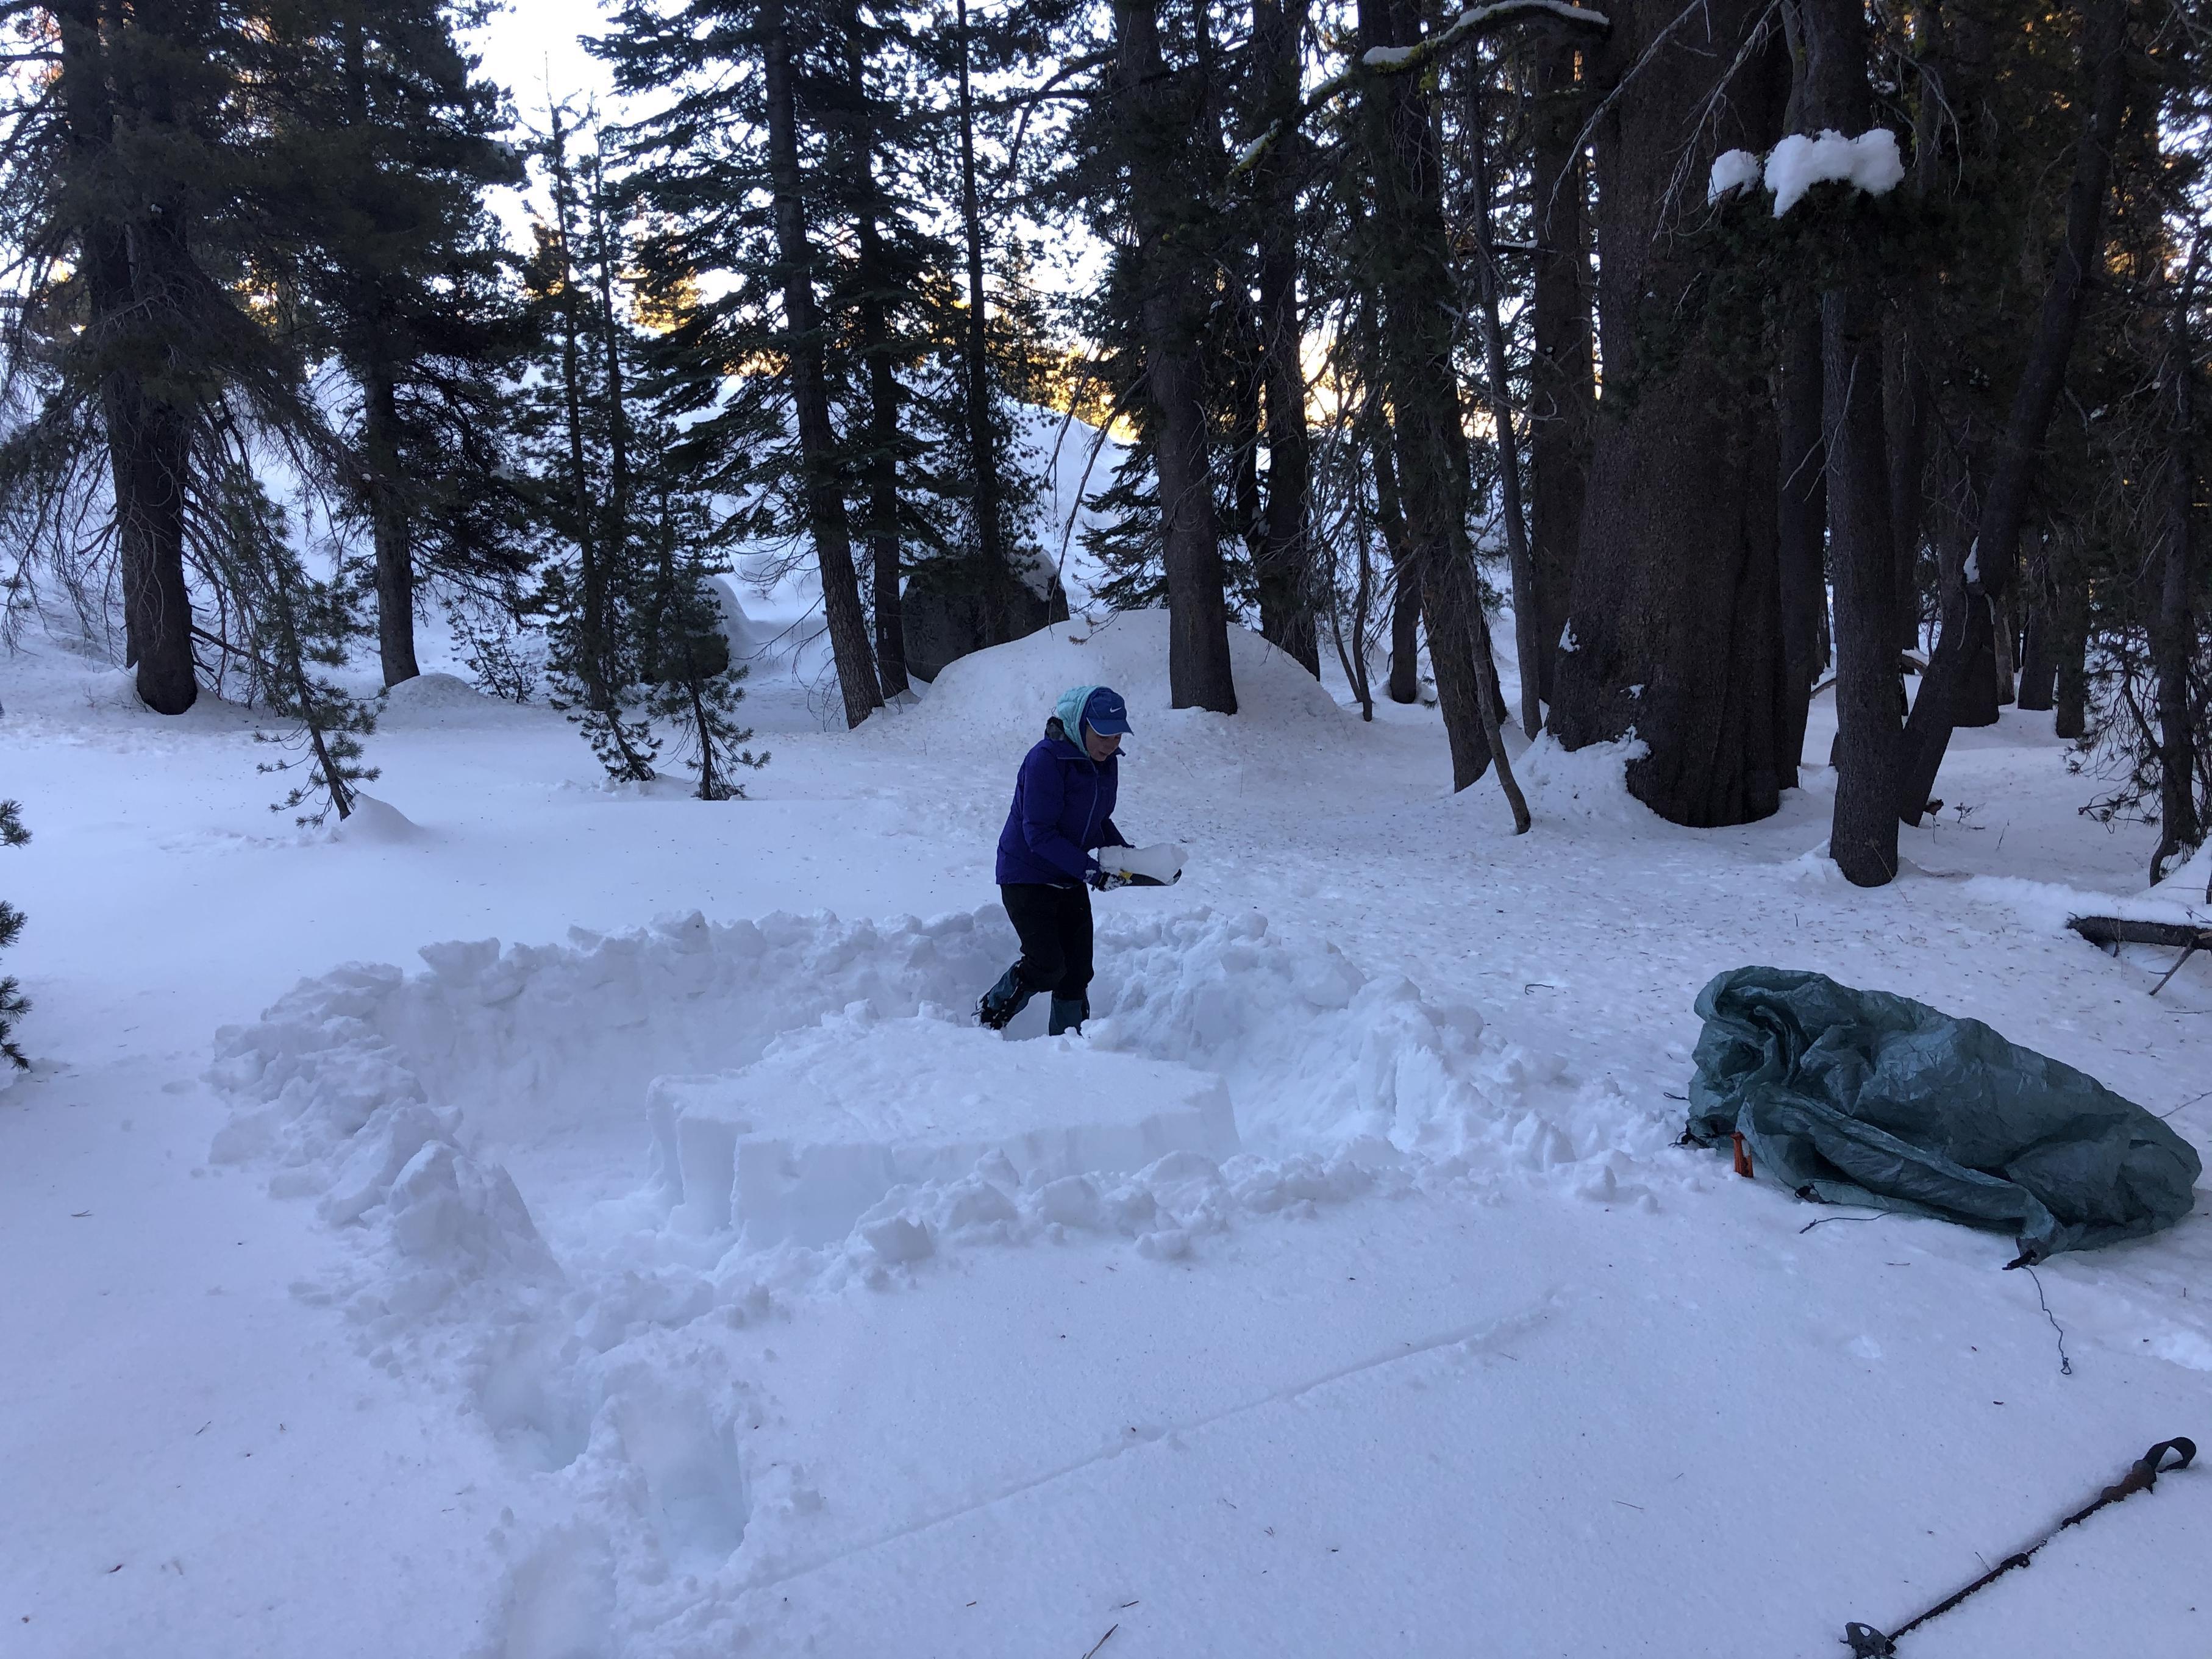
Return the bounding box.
[1803,0,1905,887]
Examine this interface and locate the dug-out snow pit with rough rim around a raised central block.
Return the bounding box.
[212,907,1666,1652]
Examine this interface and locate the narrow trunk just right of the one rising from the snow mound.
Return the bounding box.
[1252,0,1321,675]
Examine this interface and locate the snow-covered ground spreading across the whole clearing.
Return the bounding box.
[0,617,2212,1659]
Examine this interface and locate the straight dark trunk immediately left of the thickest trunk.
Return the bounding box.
[1524,38,1597,704]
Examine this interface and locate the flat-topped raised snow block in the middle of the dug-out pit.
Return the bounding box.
[648,1008,1239,1250]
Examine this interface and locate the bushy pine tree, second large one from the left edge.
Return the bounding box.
[254,0,522,686]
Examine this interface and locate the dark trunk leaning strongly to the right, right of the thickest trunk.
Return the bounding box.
[1898,0,2128,823]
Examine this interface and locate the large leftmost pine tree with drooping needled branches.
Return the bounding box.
[0,0,323,715]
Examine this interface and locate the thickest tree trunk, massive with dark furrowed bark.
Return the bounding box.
[1550,0,1787,827]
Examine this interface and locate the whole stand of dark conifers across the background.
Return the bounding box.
[0,0,2212,885]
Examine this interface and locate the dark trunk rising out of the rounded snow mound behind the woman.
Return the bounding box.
[1115,0,1236,715]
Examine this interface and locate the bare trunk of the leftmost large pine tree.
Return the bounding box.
[53,0,199,715]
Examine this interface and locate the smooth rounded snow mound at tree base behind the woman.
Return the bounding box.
[918,610,1356,754]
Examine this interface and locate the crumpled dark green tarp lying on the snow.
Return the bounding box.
[1690,966,2203,1261]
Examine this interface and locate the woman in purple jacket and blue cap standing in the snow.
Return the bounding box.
[976,686,1130,1038]
